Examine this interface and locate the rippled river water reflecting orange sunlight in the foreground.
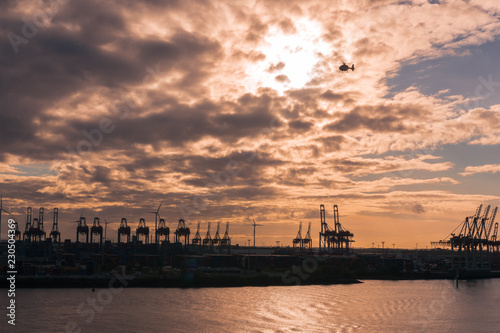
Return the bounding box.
[0,279,500,333]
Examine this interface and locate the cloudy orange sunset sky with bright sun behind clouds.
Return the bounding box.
[0,0,500,248]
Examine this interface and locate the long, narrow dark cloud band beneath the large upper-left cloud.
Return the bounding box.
[58,94,282,151]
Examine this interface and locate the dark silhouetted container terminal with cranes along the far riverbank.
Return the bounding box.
[0,201,500,287]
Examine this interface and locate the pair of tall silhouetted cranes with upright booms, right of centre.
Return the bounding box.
[319,205,354,255]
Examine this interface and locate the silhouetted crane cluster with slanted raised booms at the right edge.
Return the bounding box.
[431,204,499,270]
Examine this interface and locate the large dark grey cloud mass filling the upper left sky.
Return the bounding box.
[0,1,220,160]
